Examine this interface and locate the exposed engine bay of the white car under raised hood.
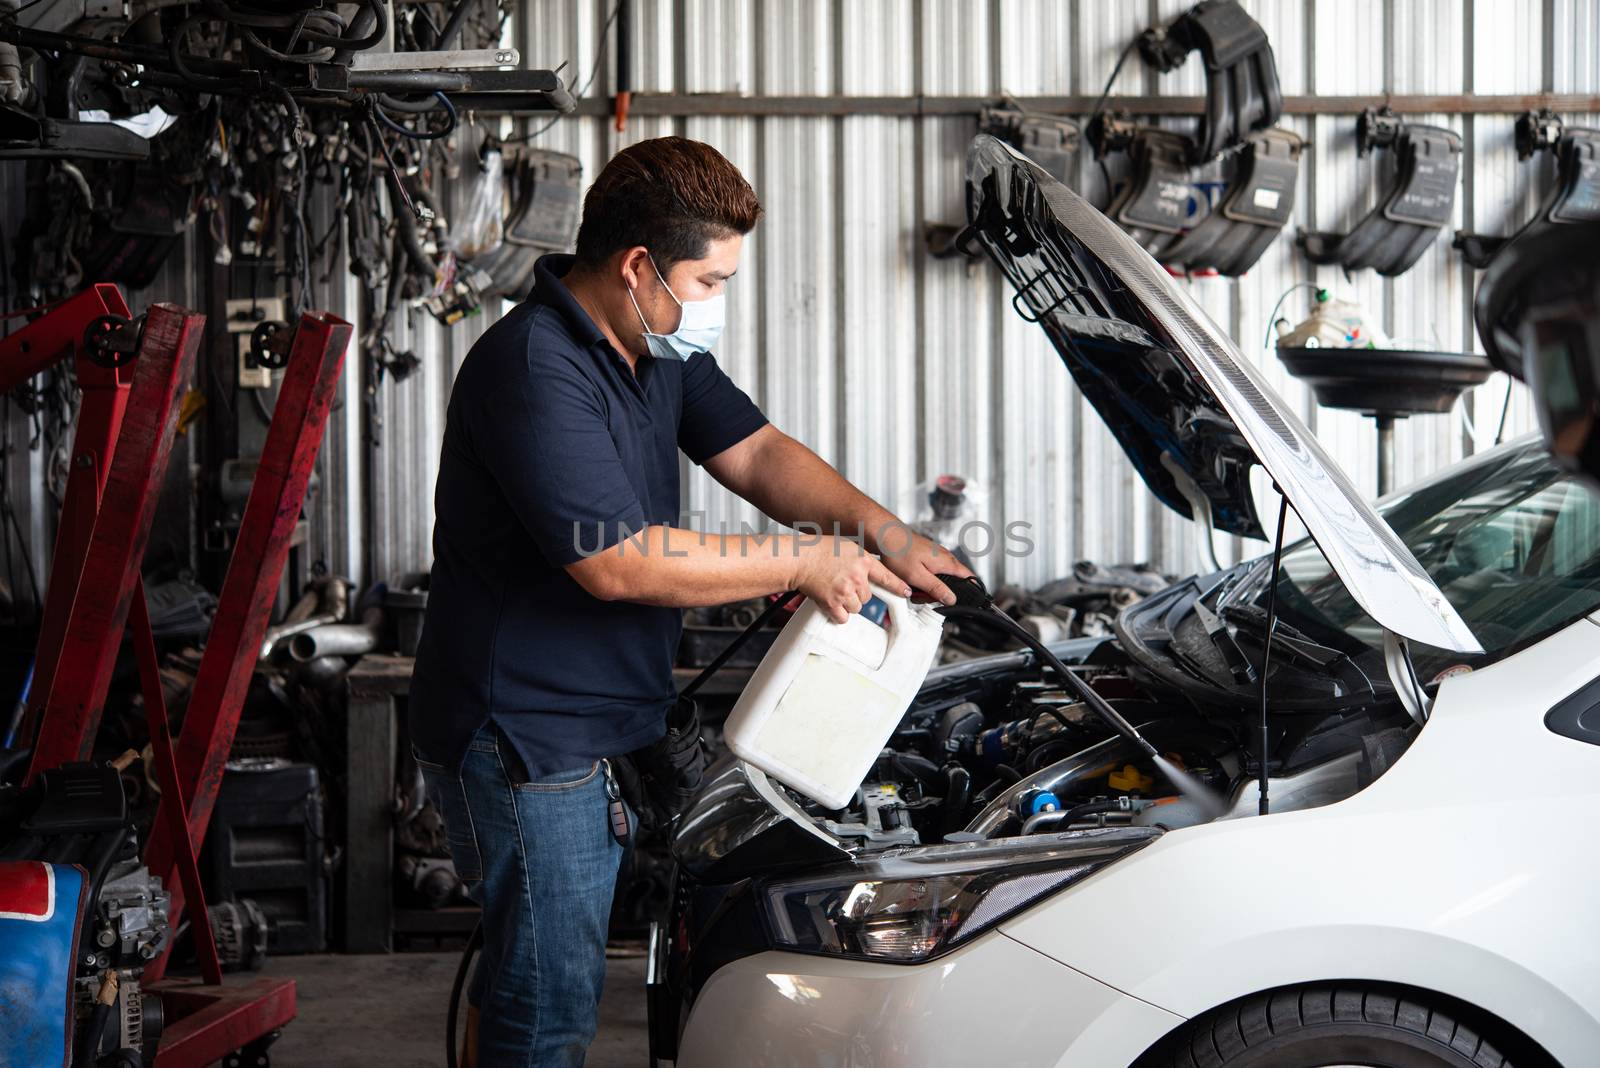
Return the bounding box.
[778,638,1418,852]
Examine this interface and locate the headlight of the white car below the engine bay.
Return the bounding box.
[762,828,1160,964]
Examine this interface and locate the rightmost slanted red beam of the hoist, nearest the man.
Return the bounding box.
[144,312,350,984]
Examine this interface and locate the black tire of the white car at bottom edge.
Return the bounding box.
[1165,983,1512,1068]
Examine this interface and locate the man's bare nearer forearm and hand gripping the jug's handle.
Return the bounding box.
[566,526,910,624]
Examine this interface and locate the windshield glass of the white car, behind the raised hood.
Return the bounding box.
[1227,440,1600,679]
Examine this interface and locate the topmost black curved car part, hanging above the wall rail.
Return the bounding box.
[1139,0,1283,163]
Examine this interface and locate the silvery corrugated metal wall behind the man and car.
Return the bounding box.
[3,0,1600,601]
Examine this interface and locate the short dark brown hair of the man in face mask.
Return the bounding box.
[578,137,762,272]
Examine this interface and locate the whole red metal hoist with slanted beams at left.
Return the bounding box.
[0,285,350,1068]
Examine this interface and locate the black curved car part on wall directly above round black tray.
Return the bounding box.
[1296,107,1461,278]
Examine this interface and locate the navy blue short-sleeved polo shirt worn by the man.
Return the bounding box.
[408,256,766,775]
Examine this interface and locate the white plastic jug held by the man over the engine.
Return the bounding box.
[725,587,944,809]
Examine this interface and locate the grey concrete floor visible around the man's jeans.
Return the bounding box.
[266,953,650,1068]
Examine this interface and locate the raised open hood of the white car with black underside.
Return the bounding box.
[966,136,1482,652]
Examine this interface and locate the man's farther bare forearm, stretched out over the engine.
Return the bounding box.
[706,424,971,604]
